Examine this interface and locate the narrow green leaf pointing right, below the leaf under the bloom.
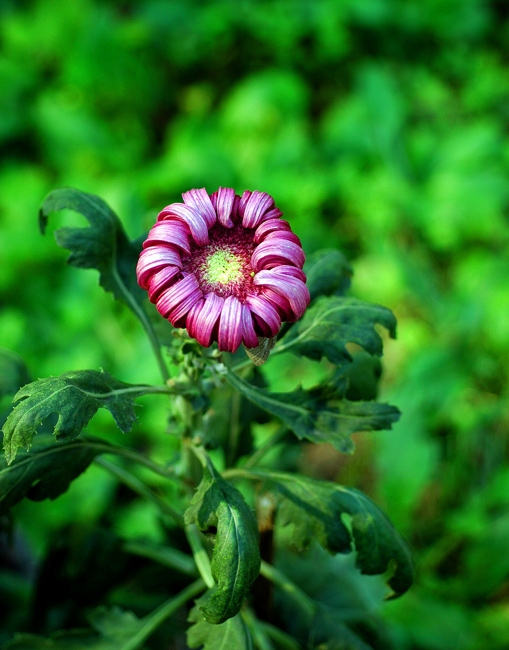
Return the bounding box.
[226,370,400,453]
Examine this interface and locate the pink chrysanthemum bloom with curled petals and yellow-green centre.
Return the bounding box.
[136,187,309,352]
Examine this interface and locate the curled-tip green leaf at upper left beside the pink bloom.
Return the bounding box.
[39,187,145,309]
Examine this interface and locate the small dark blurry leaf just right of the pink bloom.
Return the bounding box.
[304,250,352,300]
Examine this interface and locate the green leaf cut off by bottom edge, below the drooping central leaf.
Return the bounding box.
[187,599,253,650]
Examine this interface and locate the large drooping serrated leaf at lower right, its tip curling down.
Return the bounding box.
[253,471,414,596]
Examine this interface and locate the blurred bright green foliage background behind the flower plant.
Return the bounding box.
[0,0,509,650]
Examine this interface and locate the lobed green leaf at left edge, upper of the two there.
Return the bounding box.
[3,370,150,463]
